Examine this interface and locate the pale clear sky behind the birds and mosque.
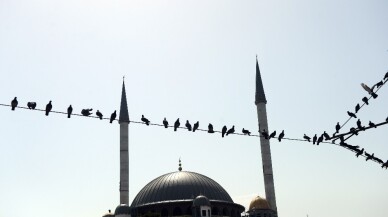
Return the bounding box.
[0,0,388,217]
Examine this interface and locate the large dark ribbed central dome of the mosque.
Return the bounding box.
[131,171,233,207]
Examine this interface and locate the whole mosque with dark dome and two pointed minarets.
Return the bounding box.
[103,59,278,217]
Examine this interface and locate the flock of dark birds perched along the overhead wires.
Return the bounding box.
[7,72,388,169]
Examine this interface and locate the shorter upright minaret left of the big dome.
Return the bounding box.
[119,81,129,204]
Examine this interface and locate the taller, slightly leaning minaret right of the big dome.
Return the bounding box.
[255,56,278,213]
